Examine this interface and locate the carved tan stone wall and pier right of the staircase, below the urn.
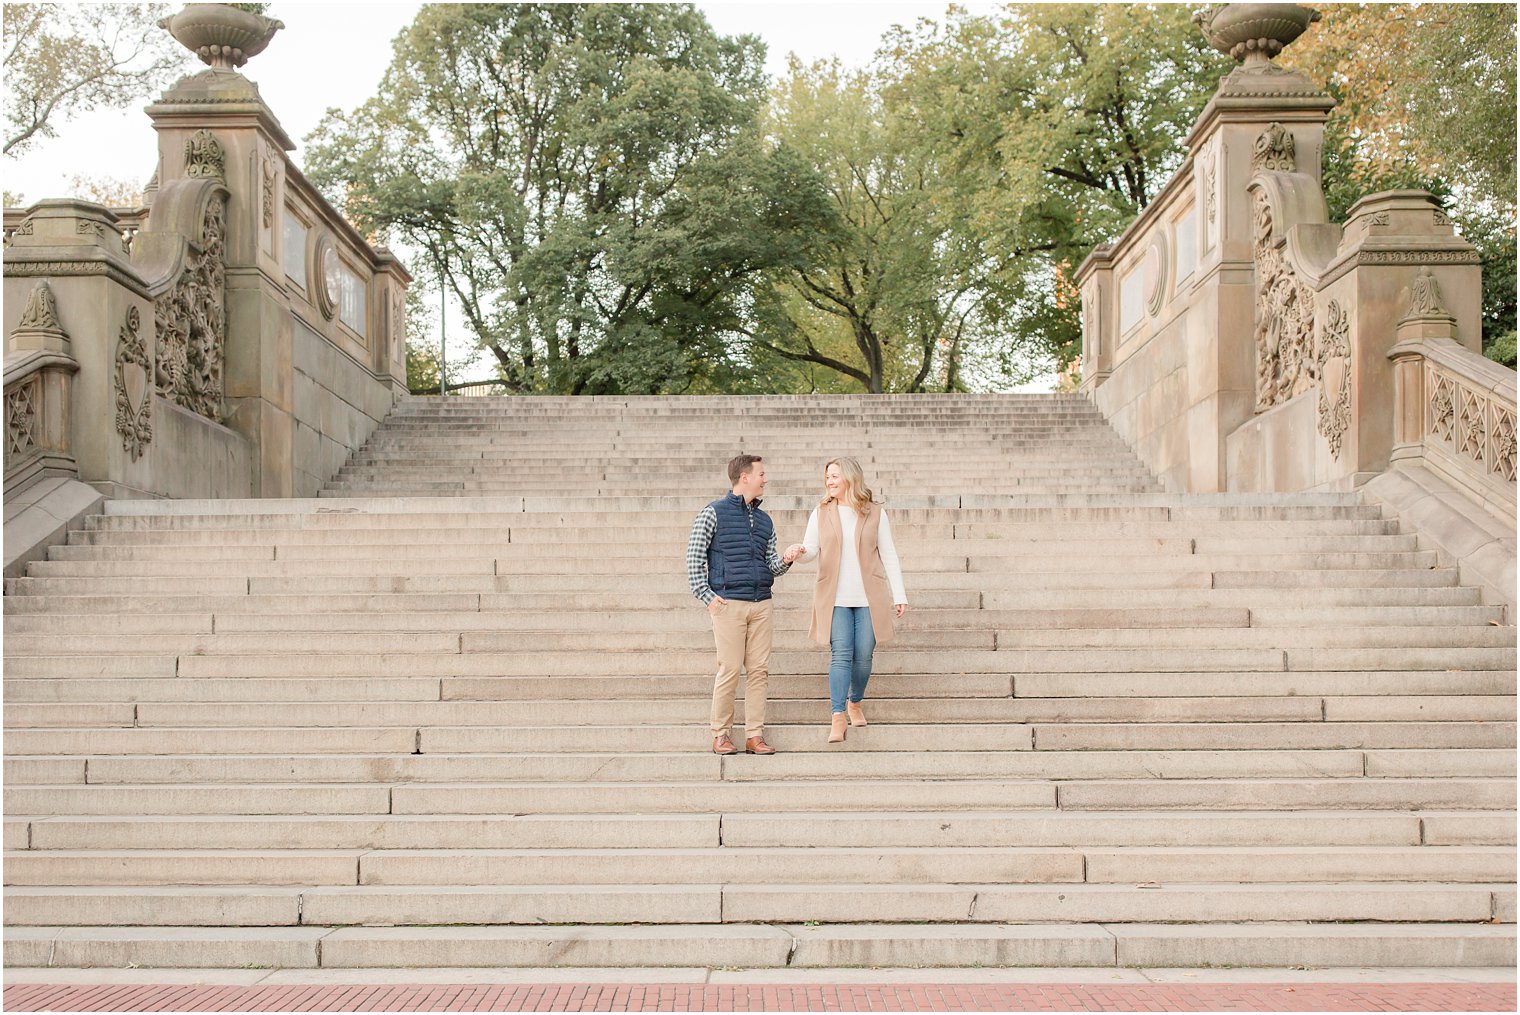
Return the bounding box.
[1076,12,1512,497]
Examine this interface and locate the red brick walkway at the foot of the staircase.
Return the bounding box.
[5,983,1515,1012]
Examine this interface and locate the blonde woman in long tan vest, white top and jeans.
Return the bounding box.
[787,459,907,743]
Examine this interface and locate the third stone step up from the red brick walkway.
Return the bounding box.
[5,838,1515,889]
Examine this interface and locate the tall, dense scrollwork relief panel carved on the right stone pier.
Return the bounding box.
[1254,190,1315,412]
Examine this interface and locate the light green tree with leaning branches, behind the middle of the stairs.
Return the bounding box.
[749,61,1045,392]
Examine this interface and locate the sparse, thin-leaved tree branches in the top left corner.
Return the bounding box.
[3,3,188,157]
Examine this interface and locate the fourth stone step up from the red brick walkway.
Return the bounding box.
[8,814,1515,850]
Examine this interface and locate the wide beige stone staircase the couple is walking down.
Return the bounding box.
[5,395,1515,969]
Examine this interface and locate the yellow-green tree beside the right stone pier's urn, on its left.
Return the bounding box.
[882,5,1228,365]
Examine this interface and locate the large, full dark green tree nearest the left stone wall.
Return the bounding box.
[309,3,824,394]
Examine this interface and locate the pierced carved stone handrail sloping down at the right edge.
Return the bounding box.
[1388,337,1515,521]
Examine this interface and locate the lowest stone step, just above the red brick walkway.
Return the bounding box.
[6,922,1515,969]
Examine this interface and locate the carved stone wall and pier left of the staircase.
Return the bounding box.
[3,8,410,573]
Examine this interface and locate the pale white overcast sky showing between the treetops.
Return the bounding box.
[5,2,991,201]
